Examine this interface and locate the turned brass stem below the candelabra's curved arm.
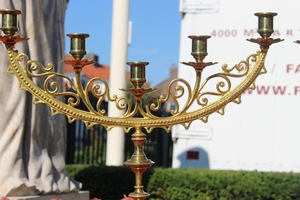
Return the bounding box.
[124,127,154,200]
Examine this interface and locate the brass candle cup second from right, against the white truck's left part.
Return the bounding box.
[189,35,210,63]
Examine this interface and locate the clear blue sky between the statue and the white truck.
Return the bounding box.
[65,0,181,87]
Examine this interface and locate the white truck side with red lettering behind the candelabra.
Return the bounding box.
[172,0,300,172]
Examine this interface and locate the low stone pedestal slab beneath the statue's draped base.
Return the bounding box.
[5,191,90,200]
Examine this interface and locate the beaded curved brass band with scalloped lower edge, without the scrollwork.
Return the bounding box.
[7,44,267,131]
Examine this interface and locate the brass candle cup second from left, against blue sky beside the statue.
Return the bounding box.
[67,33,89,60]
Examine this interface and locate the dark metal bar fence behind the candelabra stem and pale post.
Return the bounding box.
[66,115,173,167]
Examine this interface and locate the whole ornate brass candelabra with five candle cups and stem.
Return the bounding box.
[0,9,281,200]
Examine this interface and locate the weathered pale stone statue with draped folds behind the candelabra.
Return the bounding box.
[0,0,81,197]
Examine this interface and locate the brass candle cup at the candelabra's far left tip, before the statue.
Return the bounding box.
[0,9,22,36]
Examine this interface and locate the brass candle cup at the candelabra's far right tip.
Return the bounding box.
[254,12,277,39]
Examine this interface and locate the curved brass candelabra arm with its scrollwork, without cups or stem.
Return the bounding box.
[3,49,266,132]
